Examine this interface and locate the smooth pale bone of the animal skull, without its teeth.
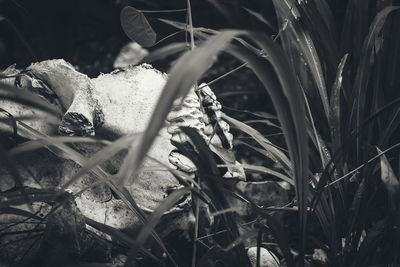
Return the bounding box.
[0,60,183,233]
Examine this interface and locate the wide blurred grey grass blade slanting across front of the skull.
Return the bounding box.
[118,31,239,187]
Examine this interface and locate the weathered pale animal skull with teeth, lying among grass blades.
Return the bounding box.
[0,60,244,266]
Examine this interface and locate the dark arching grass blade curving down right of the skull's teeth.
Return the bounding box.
[226,33,309,258]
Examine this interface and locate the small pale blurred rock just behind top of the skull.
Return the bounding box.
[114,42,149,69]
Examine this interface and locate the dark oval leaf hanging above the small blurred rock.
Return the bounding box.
[120,6,157,47]
